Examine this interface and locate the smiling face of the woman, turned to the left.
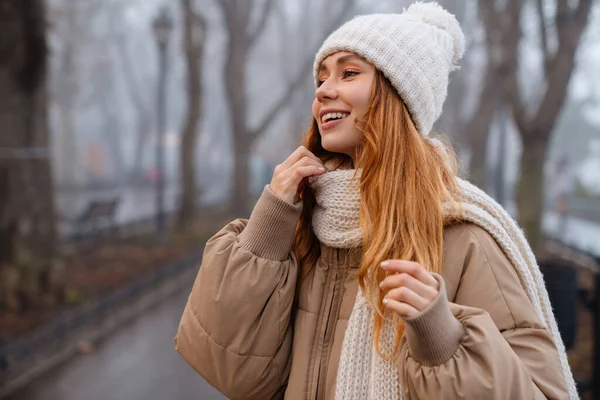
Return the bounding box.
[312,51,375,161]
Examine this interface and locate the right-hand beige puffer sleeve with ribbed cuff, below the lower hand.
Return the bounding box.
[398,225,569,400]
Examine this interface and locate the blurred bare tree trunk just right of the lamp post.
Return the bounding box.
[177,0,206,229]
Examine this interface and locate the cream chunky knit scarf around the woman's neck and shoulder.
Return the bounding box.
[310,170,579,400]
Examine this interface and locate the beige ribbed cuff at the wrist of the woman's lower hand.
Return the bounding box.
[404,274,466,367]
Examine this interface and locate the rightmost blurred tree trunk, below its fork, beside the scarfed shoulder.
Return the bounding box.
[517,132,547,258]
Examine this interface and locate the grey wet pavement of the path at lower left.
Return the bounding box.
[8,289,225,400]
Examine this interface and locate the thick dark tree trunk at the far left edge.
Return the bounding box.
[0,0,59,307]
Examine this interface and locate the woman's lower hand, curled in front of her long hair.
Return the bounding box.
[379,260,440,318]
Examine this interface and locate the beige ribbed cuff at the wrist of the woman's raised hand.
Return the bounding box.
[238,185,302,261]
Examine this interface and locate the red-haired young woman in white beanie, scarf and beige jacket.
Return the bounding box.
[175,3,577,400]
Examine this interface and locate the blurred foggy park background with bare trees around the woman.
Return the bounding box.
[0,0,600,400]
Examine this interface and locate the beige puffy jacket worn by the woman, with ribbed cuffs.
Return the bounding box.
[175,187,568,400]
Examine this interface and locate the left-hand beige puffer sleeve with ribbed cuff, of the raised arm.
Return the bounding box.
[175,186,302,399]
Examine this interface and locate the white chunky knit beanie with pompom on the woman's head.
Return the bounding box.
[314,2,465,136]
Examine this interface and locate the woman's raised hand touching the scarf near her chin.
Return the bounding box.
[269,146,327,204]
